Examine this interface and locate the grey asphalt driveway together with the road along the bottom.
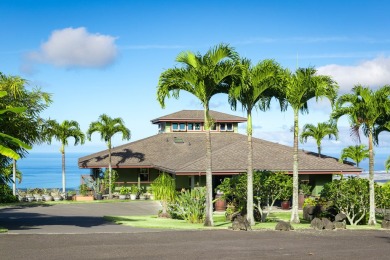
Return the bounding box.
[0,201,390,260]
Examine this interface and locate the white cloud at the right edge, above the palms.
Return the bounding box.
[317,57,390,93]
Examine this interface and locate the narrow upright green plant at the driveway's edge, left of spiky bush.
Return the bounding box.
[151,173,176,218]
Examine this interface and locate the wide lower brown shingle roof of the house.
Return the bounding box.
[79,133,361,174]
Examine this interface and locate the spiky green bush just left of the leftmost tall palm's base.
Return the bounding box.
[168,187,206,223]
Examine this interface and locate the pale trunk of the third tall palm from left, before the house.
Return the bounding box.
[290,109,300,223]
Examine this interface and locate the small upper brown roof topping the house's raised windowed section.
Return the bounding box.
[151,110,246,124]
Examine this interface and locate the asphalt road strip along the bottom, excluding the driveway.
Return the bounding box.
[0,230,390,260]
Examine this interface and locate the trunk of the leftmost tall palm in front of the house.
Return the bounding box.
[204,106,214,227]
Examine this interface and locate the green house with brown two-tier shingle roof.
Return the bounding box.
[78,110,361,197]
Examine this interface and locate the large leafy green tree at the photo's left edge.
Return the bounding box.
[0,72,51,194]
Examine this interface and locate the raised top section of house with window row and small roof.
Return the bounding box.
[151,110,247,133]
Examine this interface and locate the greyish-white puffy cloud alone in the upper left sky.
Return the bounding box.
[28,27,117,68]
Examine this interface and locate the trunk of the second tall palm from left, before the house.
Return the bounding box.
[246,113,255,226]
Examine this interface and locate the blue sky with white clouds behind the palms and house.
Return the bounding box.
[0,0,390,170]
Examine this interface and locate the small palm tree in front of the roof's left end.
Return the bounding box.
[87,114,131,199]
